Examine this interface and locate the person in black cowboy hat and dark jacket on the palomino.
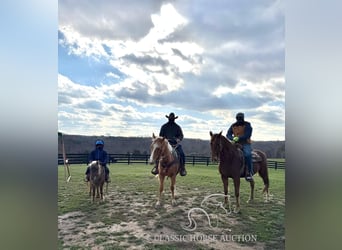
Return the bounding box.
[151,113,187,176]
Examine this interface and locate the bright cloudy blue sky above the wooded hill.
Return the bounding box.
[58,0,285,141]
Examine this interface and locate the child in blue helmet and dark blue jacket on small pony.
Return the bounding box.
[85,140,110,182]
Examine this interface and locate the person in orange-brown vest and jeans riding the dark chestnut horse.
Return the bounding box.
[226,113,254,181]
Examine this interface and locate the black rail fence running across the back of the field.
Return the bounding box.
[58,154,285,169]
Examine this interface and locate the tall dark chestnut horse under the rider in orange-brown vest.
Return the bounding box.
[210,131,269,213]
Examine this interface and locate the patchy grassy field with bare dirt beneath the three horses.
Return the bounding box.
[58,164,285,249]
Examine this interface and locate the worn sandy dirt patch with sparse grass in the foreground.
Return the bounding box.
[58,191,264,249]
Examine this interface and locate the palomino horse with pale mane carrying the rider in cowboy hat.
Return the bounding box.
[150,133,179,207]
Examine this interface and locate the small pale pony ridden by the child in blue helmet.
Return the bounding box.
[89,161,105,202]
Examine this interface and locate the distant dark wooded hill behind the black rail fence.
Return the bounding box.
[58,134,285,158]
